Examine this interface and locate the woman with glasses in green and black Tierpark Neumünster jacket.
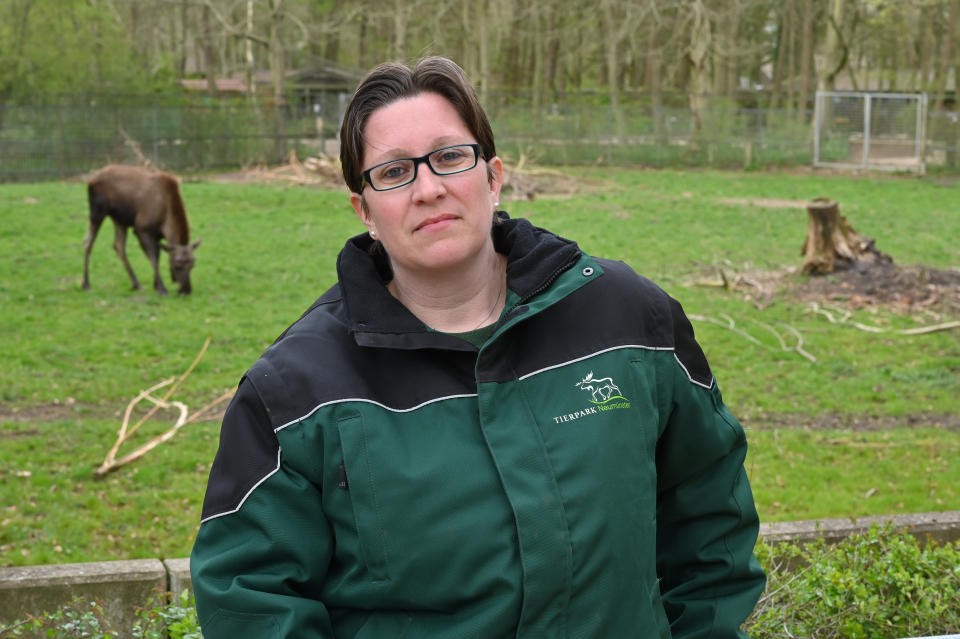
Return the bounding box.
[191,58,764,639]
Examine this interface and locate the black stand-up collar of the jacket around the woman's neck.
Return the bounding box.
[337,211,581,350]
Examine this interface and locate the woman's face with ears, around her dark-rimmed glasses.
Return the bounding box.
[350,93,503,277]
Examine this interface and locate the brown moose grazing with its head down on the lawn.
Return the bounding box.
[83,165,200,295]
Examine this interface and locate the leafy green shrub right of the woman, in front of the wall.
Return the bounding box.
[745,526,960,639]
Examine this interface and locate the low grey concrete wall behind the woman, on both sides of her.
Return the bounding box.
[0,510,960,628]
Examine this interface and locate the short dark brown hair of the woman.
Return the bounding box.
[340,56,497,193]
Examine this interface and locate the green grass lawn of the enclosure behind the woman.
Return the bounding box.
[0,169,960,565]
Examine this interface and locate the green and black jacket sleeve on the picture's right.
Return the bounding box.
[657,300,765,639]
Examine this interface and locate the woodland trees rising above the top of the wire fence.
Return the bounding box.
[0,0,960,110]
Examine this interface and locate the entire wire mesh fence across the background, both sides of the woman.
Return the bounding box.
[0,92,960,182]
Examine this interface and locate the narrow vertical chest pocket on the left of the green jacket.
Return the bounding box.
[337,415,390,581]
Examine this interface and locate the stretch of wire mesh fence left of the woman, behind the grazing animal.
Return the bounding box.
[0,96,339,182]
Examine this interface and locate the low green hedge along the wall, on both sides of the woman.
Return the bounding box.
[0,526,960,639]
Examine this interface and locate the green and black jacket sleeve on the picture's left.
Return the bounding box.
[190,378,334,639]
